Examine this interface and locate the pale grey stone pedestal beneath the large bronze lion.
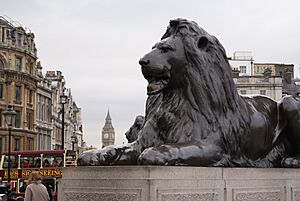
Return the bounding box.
[58,166,300,201]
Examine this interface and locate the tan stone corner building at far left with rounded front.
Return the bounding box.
[0,17,38,152]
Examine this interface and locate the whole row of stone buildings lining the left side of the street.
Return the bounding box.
[0,16,84,152]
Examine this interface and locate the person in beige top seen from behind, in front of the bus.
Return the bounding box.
[24,172,50,201]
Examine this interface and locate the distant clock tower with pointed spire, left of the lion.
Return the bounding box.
[102,111,115,148]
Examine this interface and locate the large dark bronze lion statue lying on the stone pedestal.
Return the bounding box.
[78,19,300,167]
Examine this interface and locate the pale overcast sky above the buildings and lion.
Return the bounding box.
[0,0,300,147]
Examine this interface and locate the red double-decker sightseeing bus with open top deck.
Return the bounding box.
[0,150,77,197]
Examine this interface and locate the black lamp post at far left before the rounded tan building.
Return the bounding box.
[2,105,17,196]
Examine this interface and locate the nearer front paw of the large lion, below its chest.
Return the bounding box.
[138,148,168,165]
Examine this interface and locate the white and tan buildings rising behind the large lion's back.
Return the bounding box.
[228,51,300,100]
